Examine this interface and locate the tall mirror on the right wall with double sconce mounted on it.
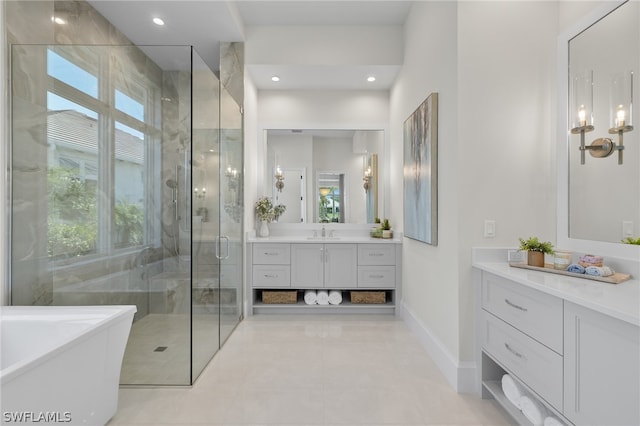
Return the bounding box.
[567,1,640,243]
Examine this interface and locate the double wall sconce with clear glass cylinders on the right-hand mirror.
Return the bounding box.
[570,71,633,164]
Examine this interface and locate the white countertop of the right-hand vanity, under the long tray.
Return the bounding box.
[473,250,640,326]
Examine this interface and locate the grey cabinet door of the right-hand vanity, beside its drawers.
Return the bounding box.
[564,301,640,425]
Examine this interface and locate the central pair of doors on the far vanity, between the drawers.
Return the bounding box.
[291,244,358,289]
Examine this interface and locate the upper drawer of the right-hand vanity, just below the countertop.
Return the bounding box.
[482,273,563,354]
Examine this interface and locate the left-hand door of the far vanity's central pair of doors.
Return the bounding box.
[291,244,324,289]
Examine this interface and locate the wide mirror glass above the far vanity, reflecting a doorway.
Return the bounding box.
[264,129,384,224]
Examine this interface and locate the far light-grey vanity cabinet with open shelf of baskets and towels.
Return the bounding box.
[246,239,402,315]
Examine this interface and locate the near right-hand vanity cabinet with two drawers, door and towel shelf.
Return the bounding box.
[475,266,640,425]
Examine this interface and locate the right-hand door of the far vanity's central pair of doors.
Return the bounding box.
[324,244,358,288]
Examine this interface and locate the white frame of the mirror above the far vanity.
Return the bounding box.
[256,122,391,226]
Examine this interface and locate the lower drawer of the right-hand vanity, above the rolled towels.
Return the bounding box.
[483,312,562,410]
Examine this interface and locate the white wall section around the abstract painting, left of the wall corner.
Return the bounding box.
[390,2,460,382]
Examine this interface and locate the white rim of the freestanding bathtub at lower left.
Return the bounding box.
[0,305,137,387]
